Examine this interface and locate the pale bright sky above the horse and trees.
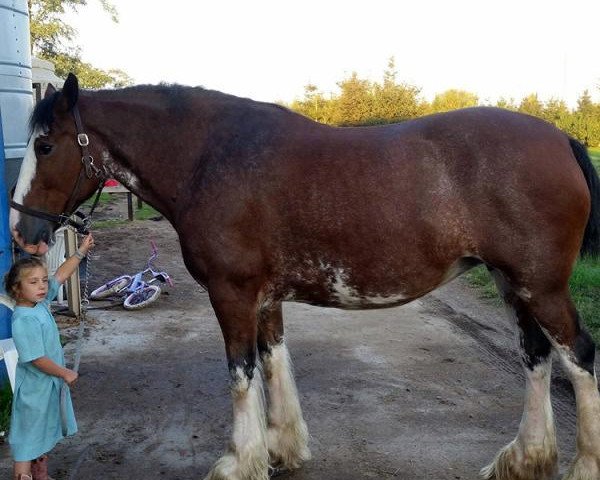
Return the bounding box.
[69,0,600,107]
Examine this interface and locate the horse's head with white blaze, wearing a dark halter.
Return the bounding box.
[10,74,99,255]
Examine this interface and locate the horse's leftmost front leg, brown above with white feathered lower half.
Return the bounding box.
[206,283,269,480]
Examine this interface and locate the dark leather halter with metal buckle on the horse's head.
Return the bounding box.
[10,105,108,235]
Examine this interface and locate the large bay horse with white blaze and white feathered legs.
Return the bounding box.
[11,75,600,480]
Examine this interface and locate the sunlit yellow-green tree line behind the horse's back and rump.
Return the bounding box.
[288,58,600,147]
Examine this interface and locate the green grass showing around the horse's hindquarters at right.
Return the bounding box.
[466,258,600,346]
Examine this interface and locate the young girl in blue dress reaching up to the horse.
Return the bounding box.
[4,234,94,480]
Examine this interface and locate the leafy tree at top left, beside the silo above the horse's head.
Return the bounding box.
[27,0,132,88]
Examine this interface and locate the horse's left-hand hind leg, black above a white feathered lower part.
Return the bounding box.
[481,271,557,480]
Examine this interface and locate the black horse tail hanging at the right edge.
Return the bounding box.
[569,137,600,257]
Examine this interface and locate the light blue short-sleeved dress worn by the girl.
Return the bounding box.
[8,277,77,462]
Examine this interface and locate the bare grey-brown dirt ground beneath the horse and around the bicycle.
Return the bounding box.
[0,196,575,480]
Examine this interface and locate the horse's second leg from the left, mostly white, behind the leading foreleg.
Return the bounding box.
[258,303,310,470]
